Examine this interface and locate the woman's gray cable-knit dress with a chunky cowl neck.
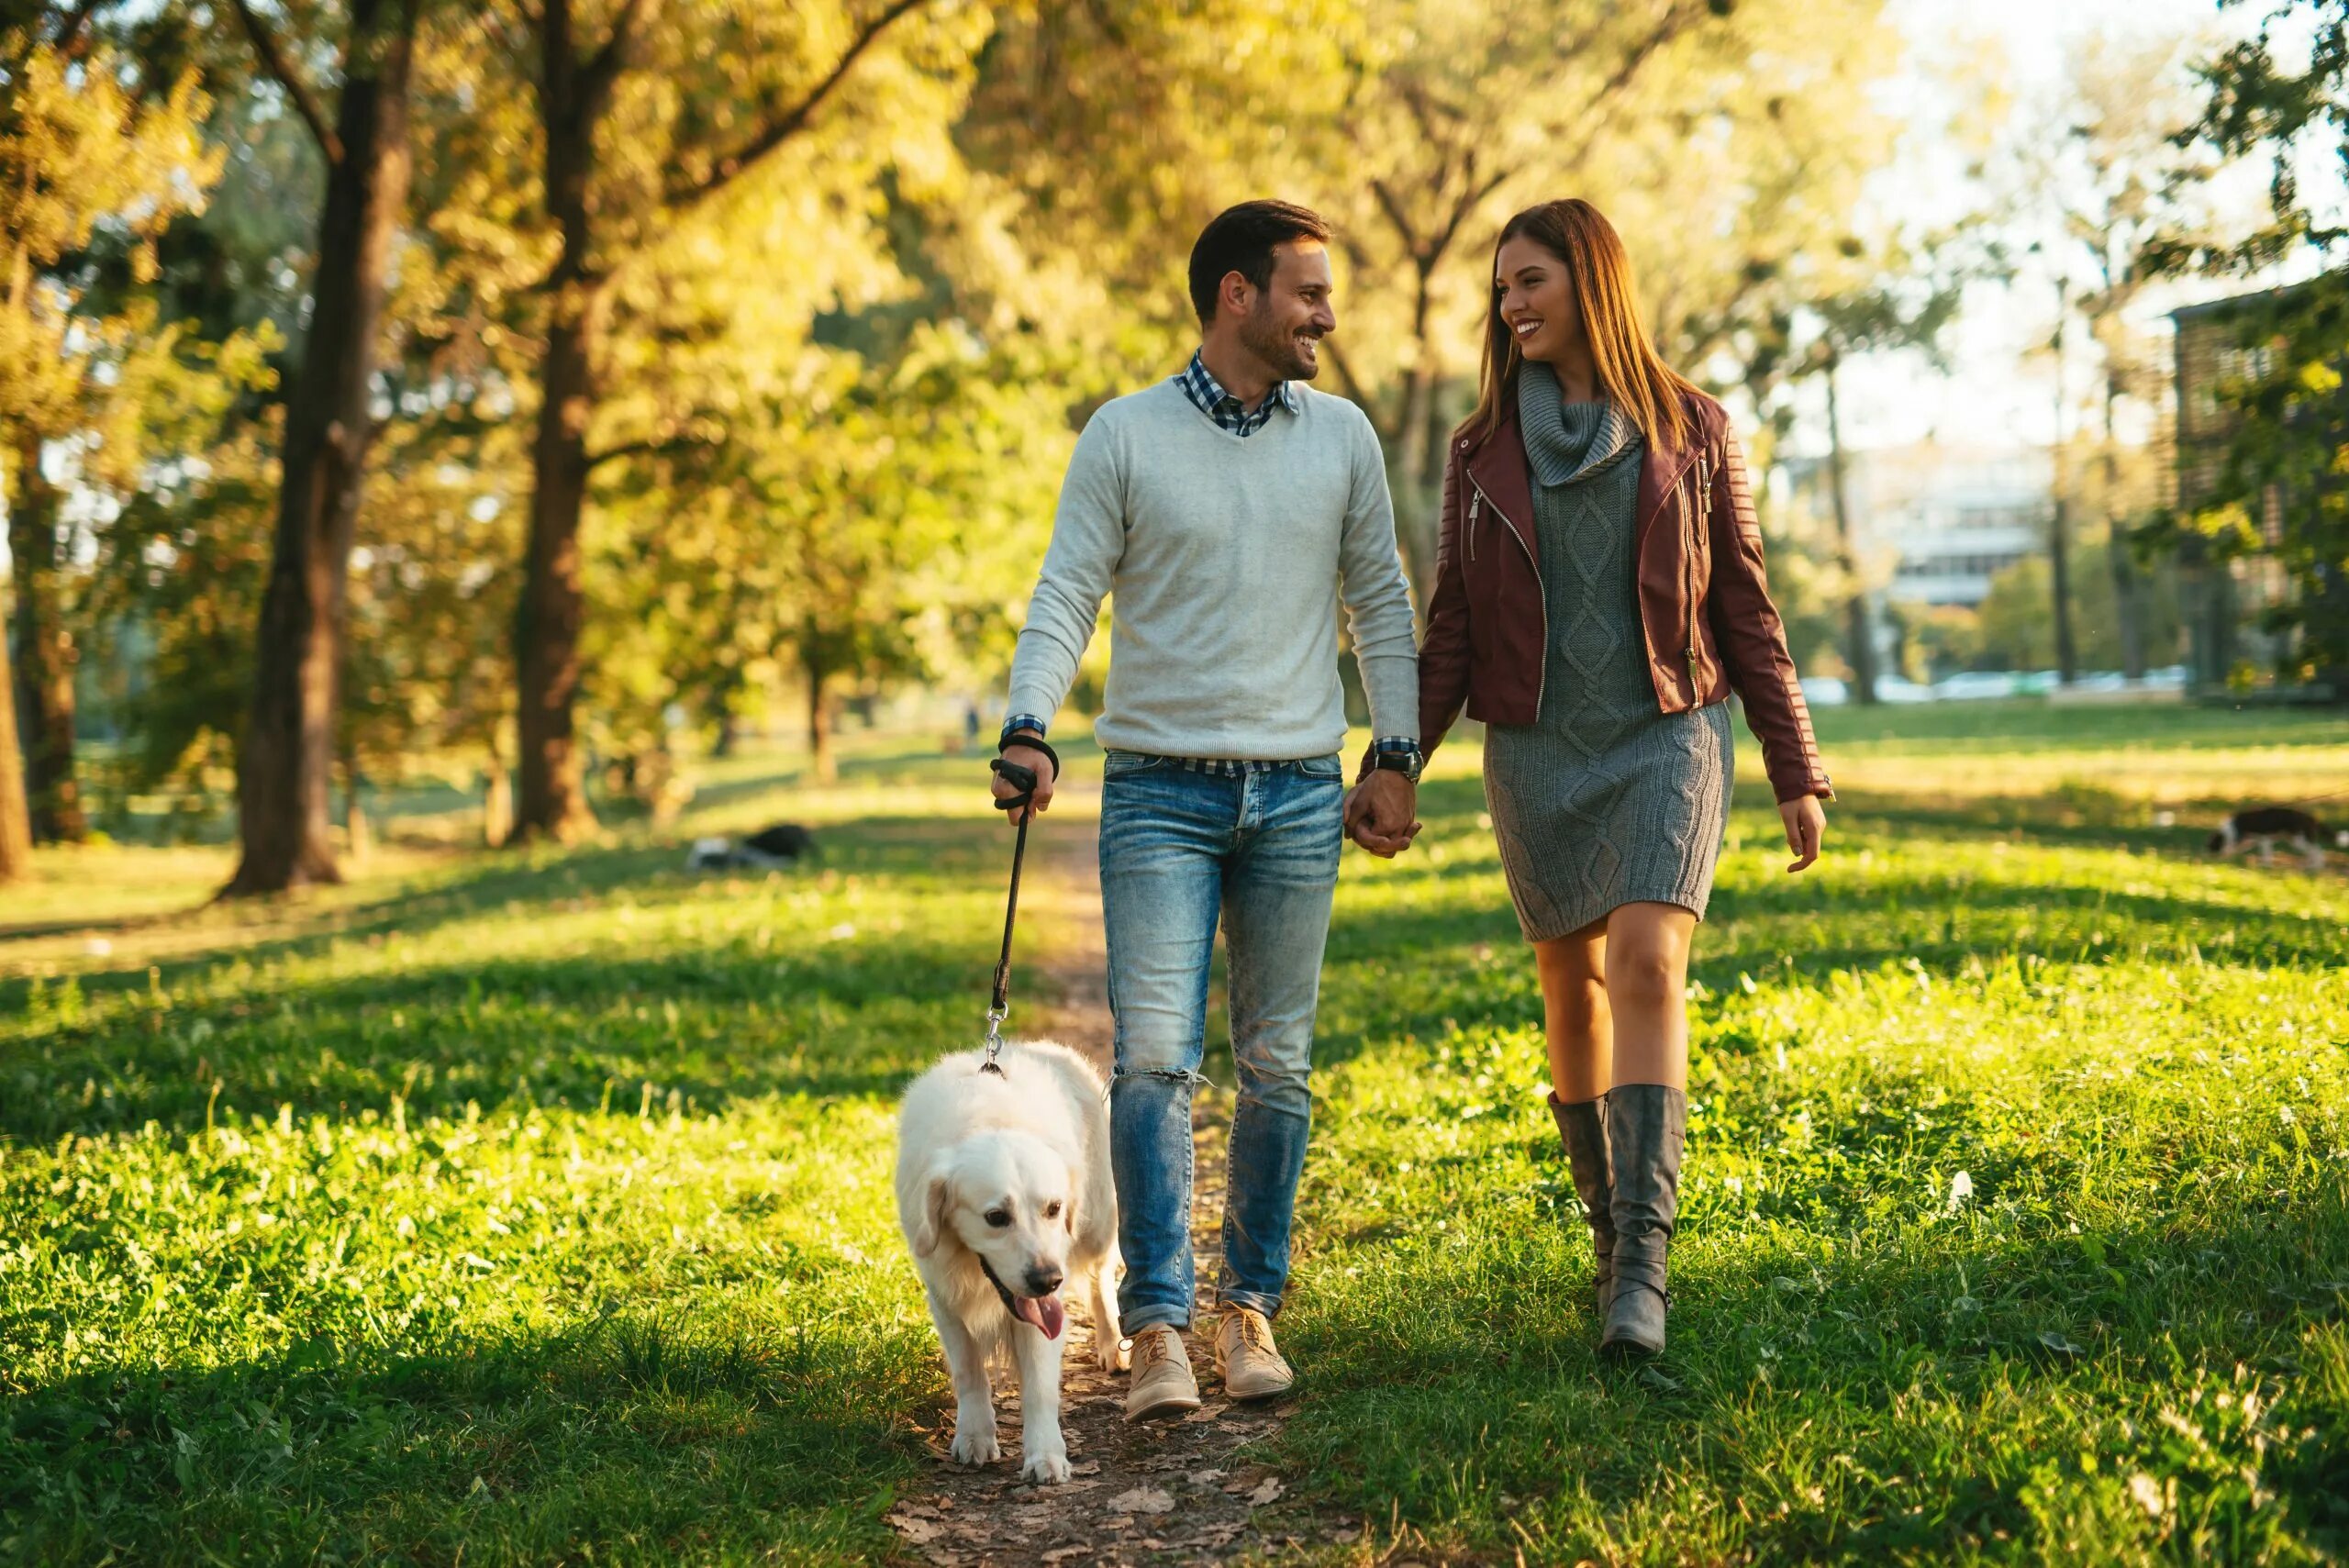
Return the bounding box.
[1485,364,1731,941]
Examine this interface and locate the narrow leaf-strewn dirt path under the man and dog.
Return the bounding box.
[888,789,1360,1568]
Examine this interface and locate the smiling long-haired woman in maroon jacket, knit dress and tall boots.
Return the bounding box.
[1362,202,1832,1354]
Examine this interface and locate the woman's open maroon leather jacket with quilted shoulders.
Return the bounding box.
[1390,395,1834,800]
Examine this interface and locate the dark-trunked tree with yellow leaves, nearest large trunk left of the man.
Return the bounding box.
[481,0,977,840]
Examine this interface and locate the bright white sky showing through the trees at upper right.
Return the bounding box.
[1790,0,2311,453]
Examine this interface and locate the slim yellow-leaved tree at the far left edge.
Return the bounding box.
[0,7,218,840]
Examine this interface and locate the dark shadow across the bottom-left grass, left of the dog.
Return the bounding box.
[0,1307,937,1563]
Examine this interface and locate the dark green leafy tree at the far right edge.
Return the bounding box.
[2147,0,2349,702]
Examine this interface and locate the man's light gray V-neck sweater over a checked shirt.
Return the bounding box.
[1010,380,1419,761]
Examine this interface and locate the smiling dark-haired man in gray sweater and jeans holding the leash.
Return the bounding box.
[996,202,1419,1420]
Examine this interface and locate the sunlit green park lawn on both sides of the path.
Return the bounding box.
[0,705,2349,1563]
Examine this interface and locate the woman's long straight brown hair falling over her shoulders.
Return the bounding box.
[1459,197,1696,446]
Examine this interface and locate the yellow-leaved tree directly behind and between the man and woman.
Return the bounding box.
[1304,0,1896,600]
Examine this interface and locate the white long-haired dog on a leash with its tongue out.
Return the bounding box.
[897,1044,1123,1481]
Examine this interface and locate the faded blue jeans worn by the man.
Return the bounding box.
[1102,751,1346,1333]
